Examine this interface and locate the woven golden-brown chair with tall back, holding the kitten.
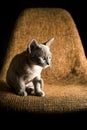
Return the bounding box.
[0,8,87,113]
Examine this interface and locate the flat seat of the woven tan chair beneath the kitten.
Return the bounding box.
[0,79,87,113]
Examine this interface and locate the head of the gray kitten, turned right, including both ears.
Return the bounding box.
[27,38,54,68]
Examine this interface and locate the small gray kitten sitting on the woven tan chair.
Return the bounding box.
[6,38,54,96]
